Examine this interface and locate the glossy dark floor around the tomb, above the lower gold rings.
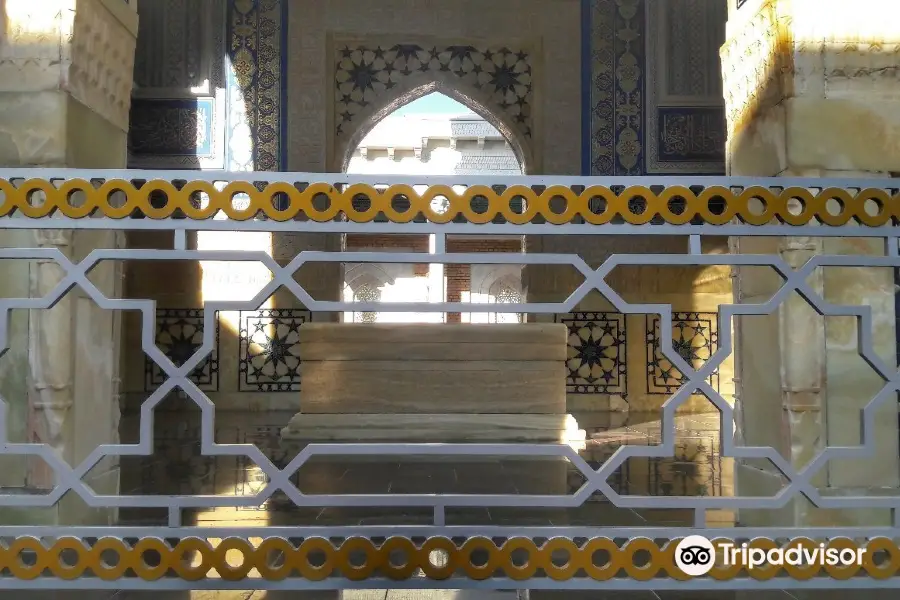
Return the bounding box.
[122,412,733,526]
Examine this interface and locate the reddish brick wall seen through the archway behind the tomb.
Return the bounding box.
[347,233,522,323]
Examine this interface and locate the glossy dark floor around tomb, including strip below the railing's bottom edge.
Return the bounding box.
[72,412,752,600]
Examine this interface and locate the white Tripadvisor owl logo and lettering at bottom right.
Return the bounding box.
[675,535,866,577]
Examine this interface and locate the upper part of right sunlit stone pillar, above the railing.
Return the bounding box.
[722,0,900,175]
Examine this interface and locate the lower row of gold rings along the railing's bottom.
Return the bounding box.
[0,537,900,581]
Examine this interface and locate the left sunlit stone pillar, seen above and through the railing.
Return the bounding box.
[0,0,137,524]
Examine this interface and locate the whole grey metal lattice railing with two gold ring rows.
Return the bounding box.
[0,169,900,589]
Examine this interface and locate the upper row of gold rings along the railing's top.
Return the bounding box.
[0,179,900,227]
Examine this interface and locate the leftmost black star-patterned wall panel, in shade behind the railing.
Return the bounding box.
[144,308,219,392]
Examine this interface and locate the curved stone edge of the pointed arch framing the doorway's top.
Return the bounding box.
[335,75,536,175]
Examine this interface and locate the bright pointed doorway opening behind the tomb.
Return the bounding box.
[343,92,523,323]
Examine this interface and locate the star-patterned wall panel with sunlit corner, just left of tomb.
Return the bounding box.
[238,308,310,392]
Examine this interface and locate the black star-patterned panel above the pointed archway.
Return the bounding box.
[334,44,533,138]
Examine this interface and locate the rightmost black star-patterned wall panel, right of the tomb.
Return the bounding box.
[647,313,719,394]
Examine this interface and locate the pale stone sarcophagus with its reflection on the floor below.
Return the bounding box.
[282,323,585,502]
